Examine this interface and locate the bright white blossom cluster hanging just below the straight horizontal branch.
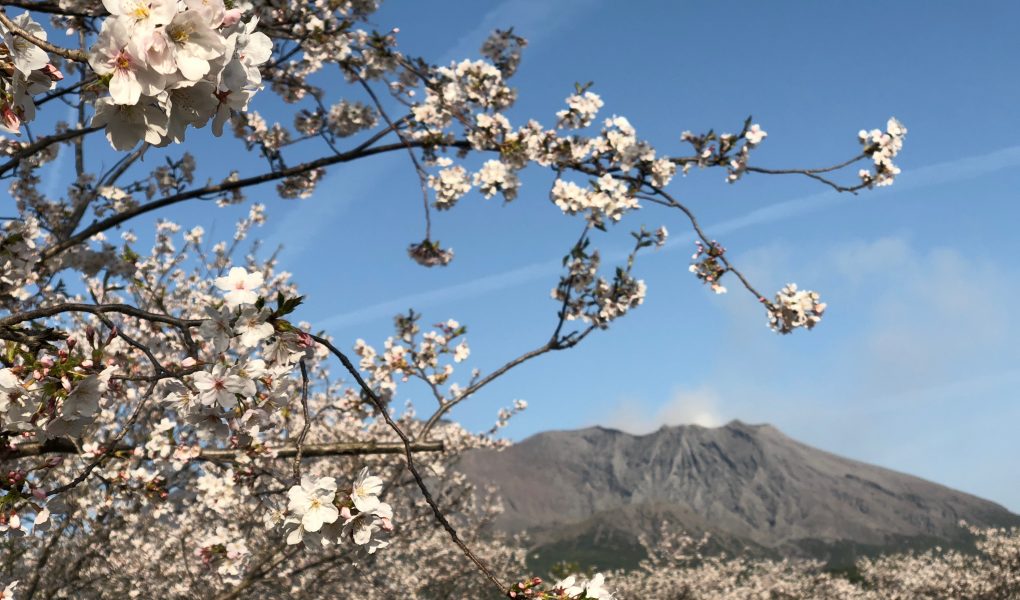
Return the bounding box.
[266,467,393,554]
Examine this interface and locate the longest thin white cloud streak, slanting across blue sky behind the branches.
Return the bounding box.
[316,146,1020,330]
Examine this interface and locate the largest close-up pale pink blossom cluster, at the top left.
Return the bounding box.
[88,0,272,150]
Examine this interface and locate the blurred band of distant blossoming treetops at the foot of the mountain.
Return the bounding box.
[595,524,1020,600]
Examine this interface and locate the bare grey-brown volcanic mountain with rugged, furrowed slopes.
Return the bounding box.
[459,421,1020,567]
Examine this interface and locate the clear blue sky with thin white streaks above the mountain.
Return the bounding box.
[21,0,1020,511]
